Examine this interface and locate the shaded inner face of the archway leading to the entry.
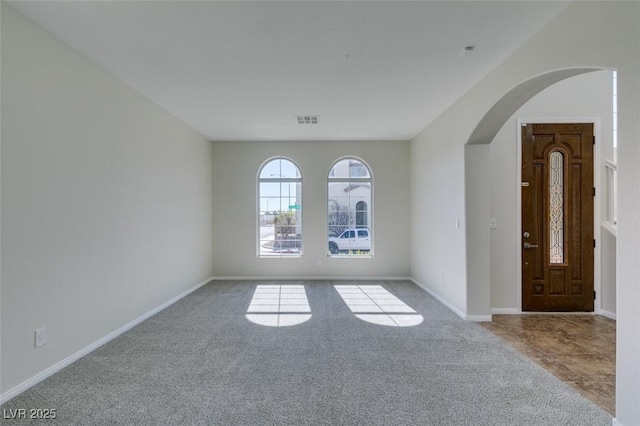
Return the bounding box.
[464,68,603,319]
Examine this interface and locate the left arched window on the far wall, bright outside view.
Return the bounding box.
[258,158,302,257]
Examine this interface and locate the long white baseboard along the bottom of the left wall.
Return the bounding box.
[0,278,212,405]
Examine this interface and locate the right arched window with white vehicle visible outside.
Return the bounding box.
[327,157,373,256]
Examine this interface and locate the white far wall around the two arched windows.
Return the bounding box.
[213,141,410,278]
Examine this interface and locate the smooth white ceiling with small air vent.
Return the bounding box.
[11,1,568,140]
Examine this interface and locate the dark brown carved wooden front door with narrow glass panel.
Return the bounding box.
[521,123,594,312]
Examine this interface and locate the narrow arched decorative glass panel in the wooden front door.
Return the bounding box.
[549,151,564,263]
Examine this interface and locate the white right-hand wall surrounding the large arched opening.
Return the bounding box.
[411,1,640,425]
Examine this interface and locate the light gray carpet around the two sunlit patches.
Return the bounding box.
[2,281,612,426]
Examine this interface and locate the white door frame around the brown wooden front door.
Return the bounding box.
[515,117,603,314]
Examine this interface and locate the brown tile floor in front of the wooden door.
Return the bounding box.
[482,314,616,416]
